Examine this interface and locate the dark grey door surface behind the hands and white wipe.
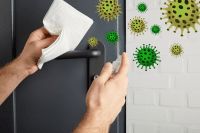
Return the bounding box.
[0,0,125,133]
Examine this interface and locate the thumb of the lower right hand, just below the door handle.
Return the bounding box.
[99,63,113,83]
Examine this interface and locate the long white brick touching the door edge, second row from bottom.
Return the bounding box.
[126,105,169,122]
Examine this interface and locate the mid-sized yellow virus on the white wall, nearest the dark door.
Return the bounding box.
[129,17,147,36]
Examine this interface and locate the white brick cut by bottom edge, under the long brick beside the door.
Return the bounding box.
[133,124,157,133]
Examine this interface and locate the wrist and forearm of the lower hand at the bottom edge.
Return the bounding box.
[73,113,110,133]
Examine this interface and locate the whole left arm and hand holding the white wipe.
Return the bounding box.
[0,28,56,105]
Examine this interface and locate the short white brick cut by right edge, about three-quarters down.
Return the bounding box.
[188,91,200,107]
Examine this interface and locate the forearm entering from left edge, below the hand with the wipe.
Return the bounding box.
[0,59,28,105]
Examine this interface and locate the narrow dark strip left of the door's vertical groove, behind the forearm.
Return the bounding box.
[0,0,13,133]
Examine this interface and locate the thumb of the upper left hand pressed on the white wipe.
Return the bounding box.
[37,36,57,49]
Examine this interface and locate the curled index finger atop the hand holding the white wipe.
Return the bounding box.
[27,27,50,43]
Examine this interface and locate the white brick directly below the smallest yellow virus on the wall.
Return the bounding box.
[160,55,186,73]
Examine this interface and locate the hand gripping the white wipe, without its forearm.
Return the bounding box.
[16,27,57,75]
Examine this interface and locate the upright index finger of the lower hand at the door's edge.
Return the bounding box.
[116,53,128,76]
